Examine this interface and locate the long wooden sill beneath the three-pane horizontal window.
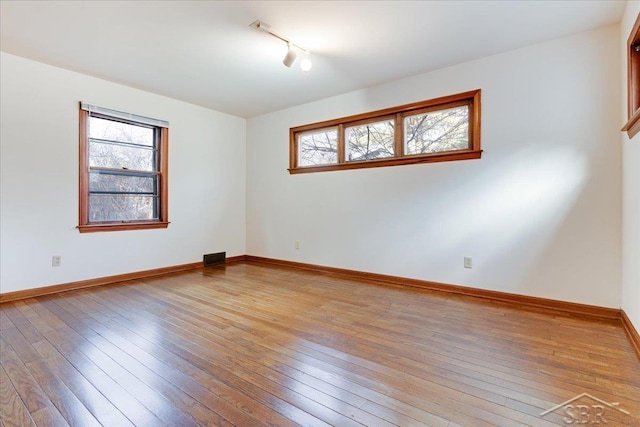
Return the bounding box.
[288,150,482,174]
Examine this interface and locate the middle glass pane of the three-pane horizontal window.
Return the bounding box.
[344,119,395,161]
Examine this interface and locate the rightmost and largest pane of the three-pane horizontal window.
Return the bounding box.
[404,105,469,155]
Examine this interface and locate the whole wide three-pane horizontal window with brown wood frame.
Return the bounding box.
[289,89,482,173]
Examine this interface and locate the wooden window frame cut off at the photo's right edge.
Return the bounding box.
[622,14,640,138]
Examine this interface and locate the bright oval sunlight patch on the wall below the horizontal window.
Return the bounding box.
[448,143,588,290]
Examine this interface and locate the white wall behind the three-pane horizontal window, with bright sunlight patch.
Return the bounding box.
[247,25,622,308]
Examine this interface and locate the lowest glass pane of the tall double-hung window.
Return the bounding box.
[89,194,158,222]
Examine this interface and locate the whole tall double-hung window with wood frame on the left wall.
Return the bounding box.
[78,103,169,233]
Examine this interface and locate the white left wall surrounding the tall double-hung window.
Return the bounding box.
[0,53,246,293]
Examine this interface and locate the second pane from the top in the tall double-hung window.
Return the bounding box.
[89,140,156,172]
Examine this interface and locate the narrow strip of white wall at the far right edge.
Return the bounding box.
[620,1,640,331]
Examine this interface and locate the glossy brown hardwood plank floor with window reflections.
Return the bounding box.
[0,263,640,427]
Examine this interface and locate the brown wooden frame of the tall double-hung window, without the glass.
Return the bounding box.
[78,108,169,233]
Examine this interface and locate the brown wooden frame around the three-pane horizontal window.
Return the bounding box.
[288,89,482,174]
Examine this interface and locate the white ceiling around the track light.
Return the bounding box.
[0,0,626,117]
